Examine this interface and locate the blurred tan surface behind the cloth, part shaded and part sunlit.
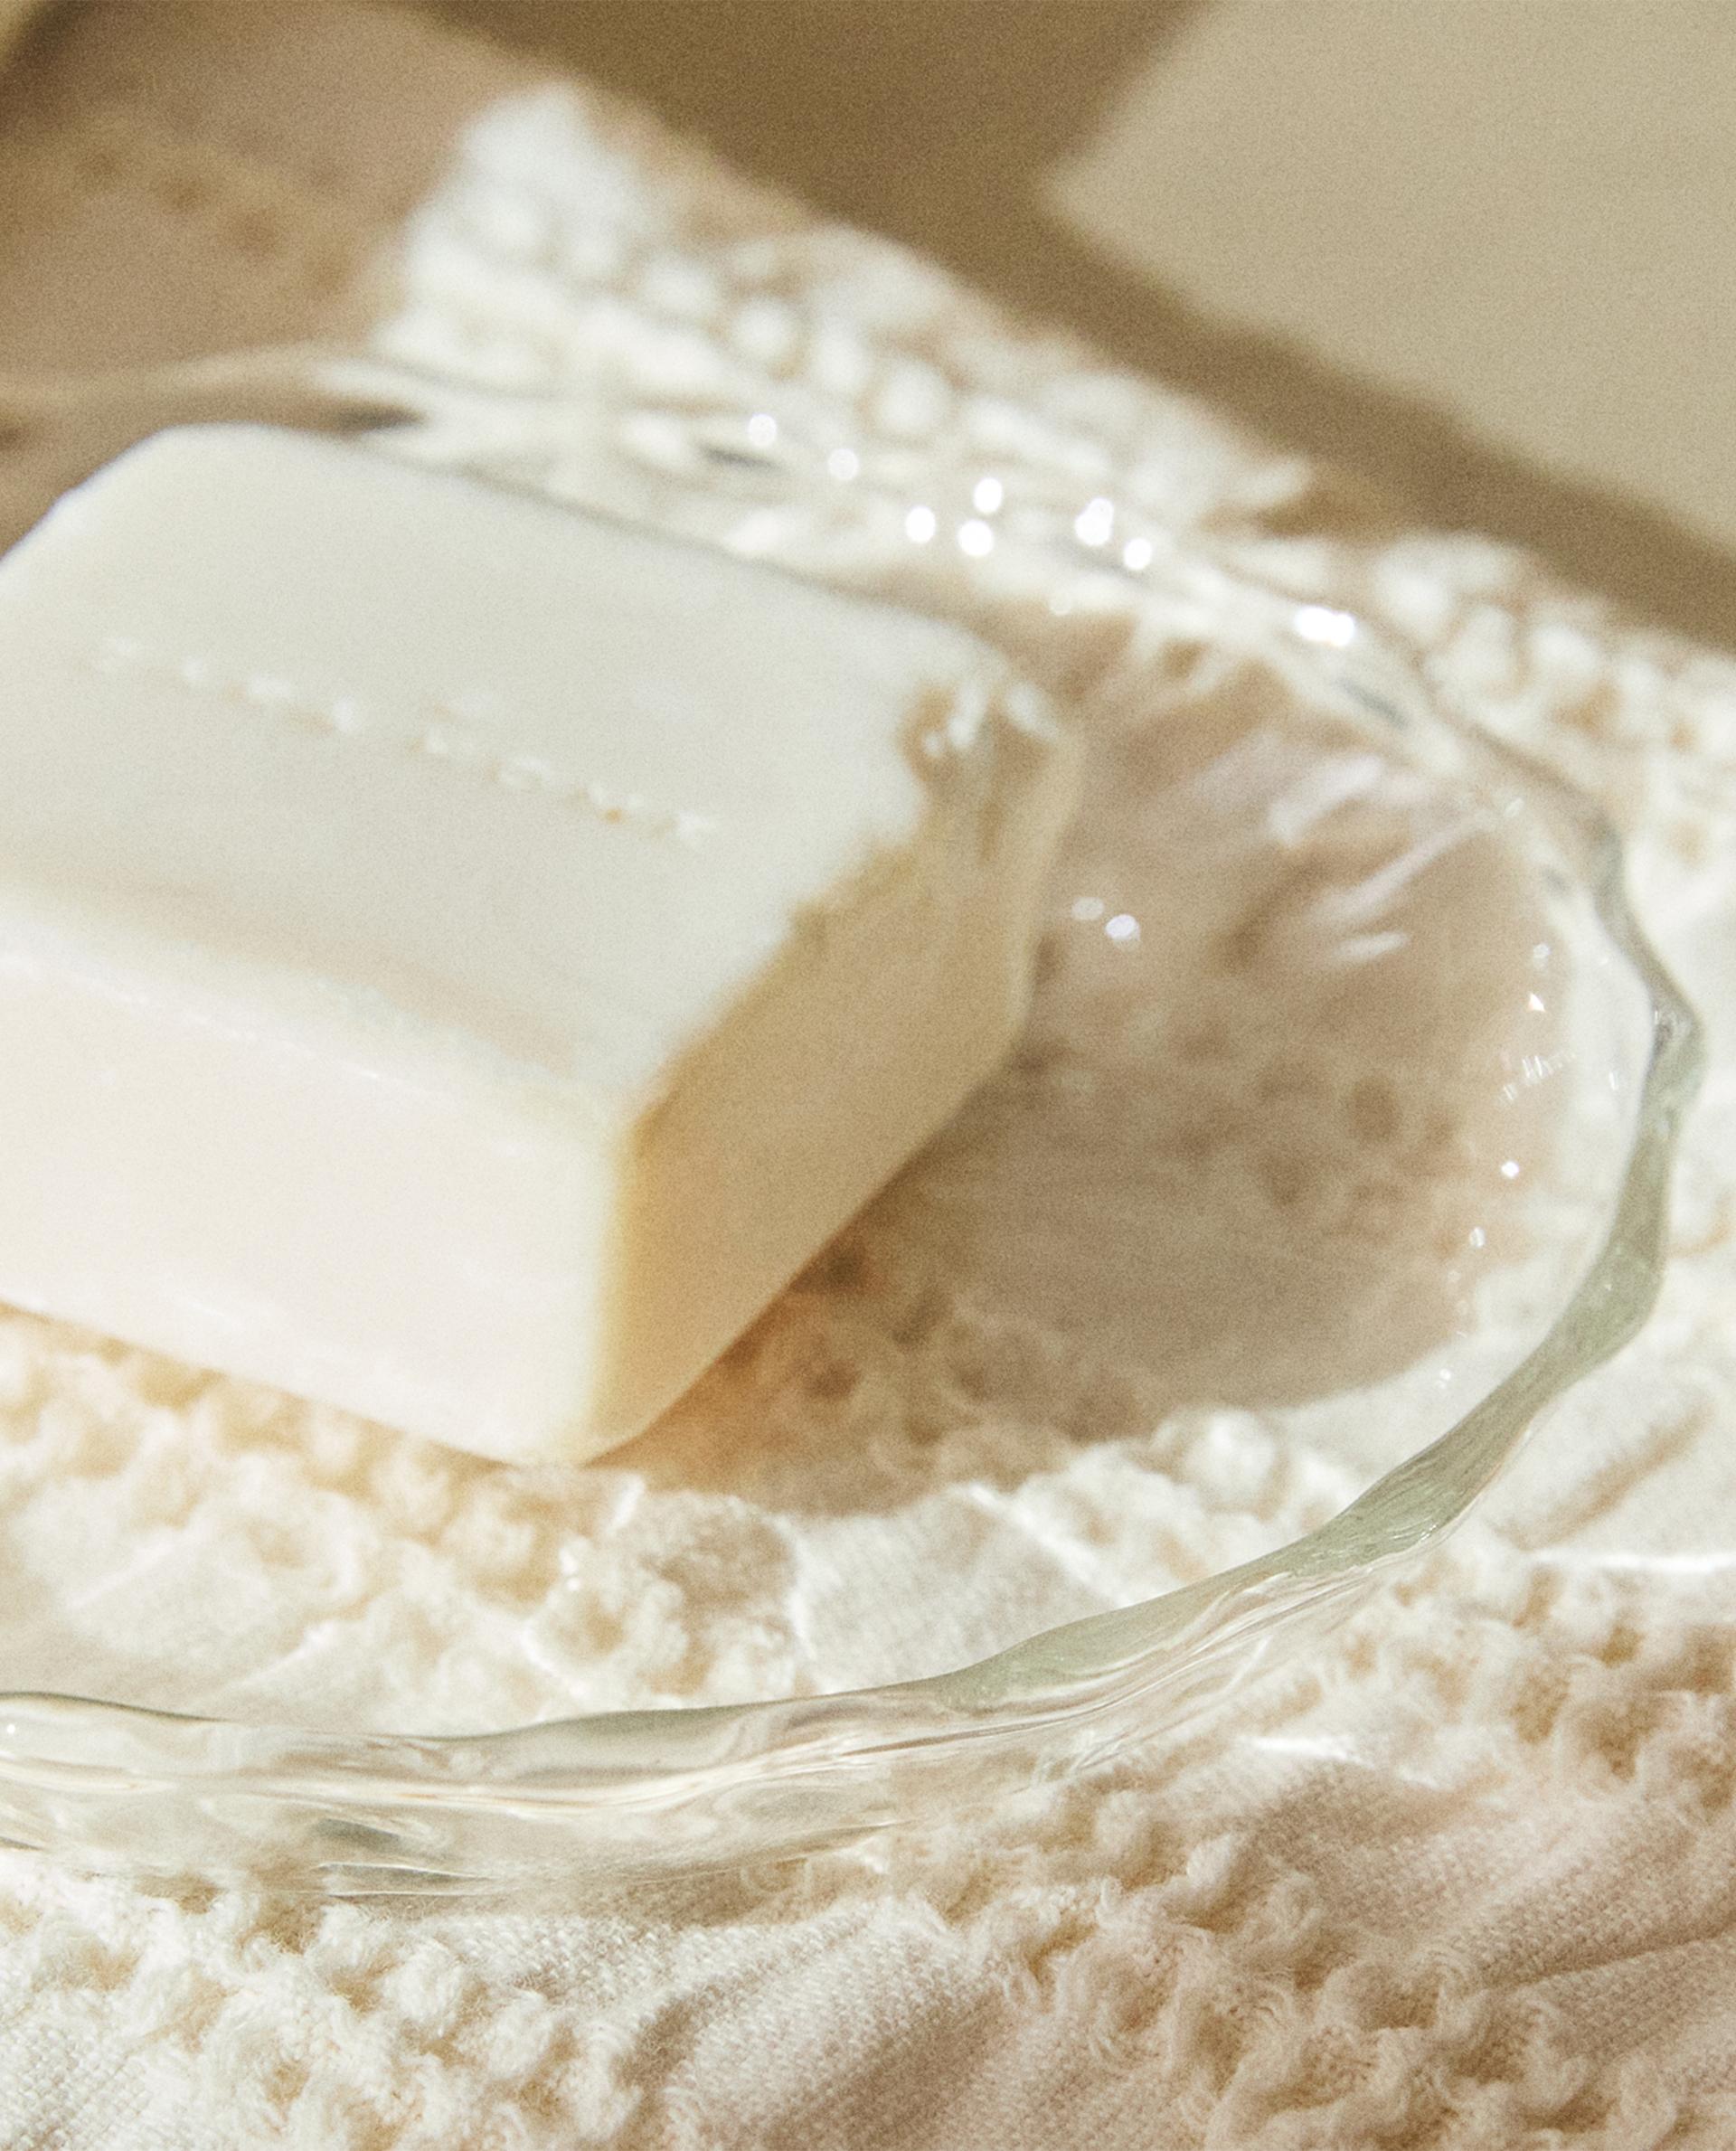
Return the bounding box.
[439,0,1736,643]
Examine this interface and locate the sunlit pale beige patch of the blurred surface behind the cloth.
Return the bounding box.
[1054,0,1736,546]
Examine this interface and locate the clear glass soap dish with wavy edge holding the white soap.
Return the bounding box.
[0,368,1700,1891]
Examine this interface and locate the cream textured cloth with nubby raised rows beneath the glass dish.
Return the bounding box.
[0,6,1736,2151]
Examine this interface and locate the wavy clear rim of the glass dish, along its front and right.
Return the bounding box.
[0,561,1703,1893]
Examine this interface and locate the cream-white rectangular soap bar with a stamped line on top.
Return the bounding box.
[0,426,1073,1460]
